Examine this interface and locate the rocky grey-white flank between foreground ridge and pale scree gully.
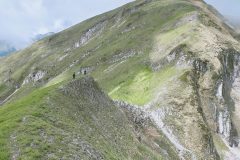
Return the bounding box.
[114,100,180,159]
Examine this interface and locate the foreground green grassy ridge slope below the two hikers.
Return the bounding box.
[0,78,178,160]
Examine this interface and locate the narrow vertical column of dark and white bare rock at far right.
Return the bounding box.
[217,49,240,147]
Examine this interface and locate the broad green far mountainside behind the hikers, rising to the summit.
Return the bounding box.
[0,0,195,104]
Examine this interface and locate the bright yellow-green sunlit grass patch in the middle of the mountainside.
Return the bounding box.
[109,66,178,105]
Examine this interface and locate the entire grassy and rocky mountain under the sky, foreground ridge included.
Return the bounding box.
[0,0,240,160]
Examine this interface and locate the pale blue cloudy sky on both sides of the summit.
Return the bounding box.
[0,0,240,49]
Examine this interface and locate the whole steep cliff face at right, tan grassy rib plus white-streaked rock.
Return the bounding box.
[192,49,240,159]
